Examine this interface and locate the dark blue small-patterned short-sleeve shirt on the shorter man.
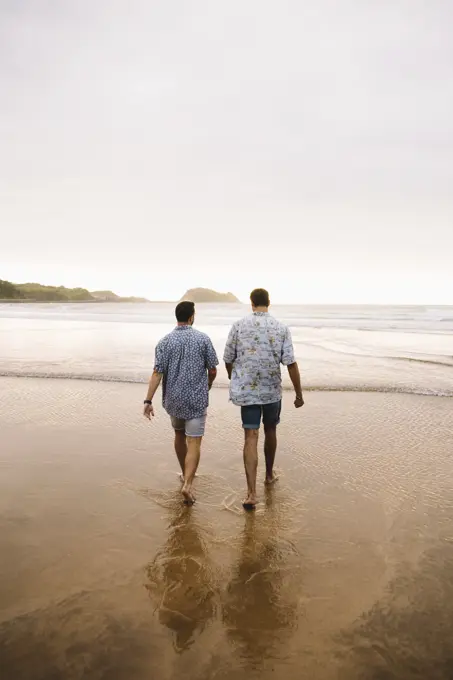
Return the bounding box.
[154,326,219,420]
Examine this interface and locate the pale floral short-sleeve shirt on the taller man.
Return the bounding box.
[223,312,295,406]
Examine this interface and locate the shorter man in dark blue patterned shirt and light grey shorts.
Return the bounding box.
[144,302,219,505]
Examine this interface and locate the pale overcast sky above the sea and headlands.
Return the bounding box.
[0,0,453,303]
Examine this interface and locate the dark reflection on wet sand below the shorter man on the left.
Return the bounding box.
[146,499,216,652]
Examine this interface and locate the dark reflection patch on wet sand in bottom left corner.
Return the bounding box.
[0,584,161,680]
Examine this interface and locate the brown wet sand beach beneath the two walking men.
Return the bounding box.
[0,378,453,680]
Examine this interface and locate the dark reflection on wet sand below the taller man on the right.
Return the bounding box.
[222,490,300,668]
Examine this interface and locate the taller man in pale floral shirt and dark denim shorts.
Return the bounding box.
[223,288,304,510]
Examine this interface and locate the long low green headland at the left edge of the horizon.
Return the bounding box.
[0,279,149,302]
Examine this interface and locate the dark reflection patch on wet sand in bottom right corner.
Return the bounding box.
[338,541,453,680]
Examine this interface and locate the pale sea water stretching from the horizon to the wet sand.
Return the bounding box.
[0,303,453,396]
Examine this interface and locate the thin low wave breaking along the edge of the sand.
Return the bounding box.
[0,370,453,398]
